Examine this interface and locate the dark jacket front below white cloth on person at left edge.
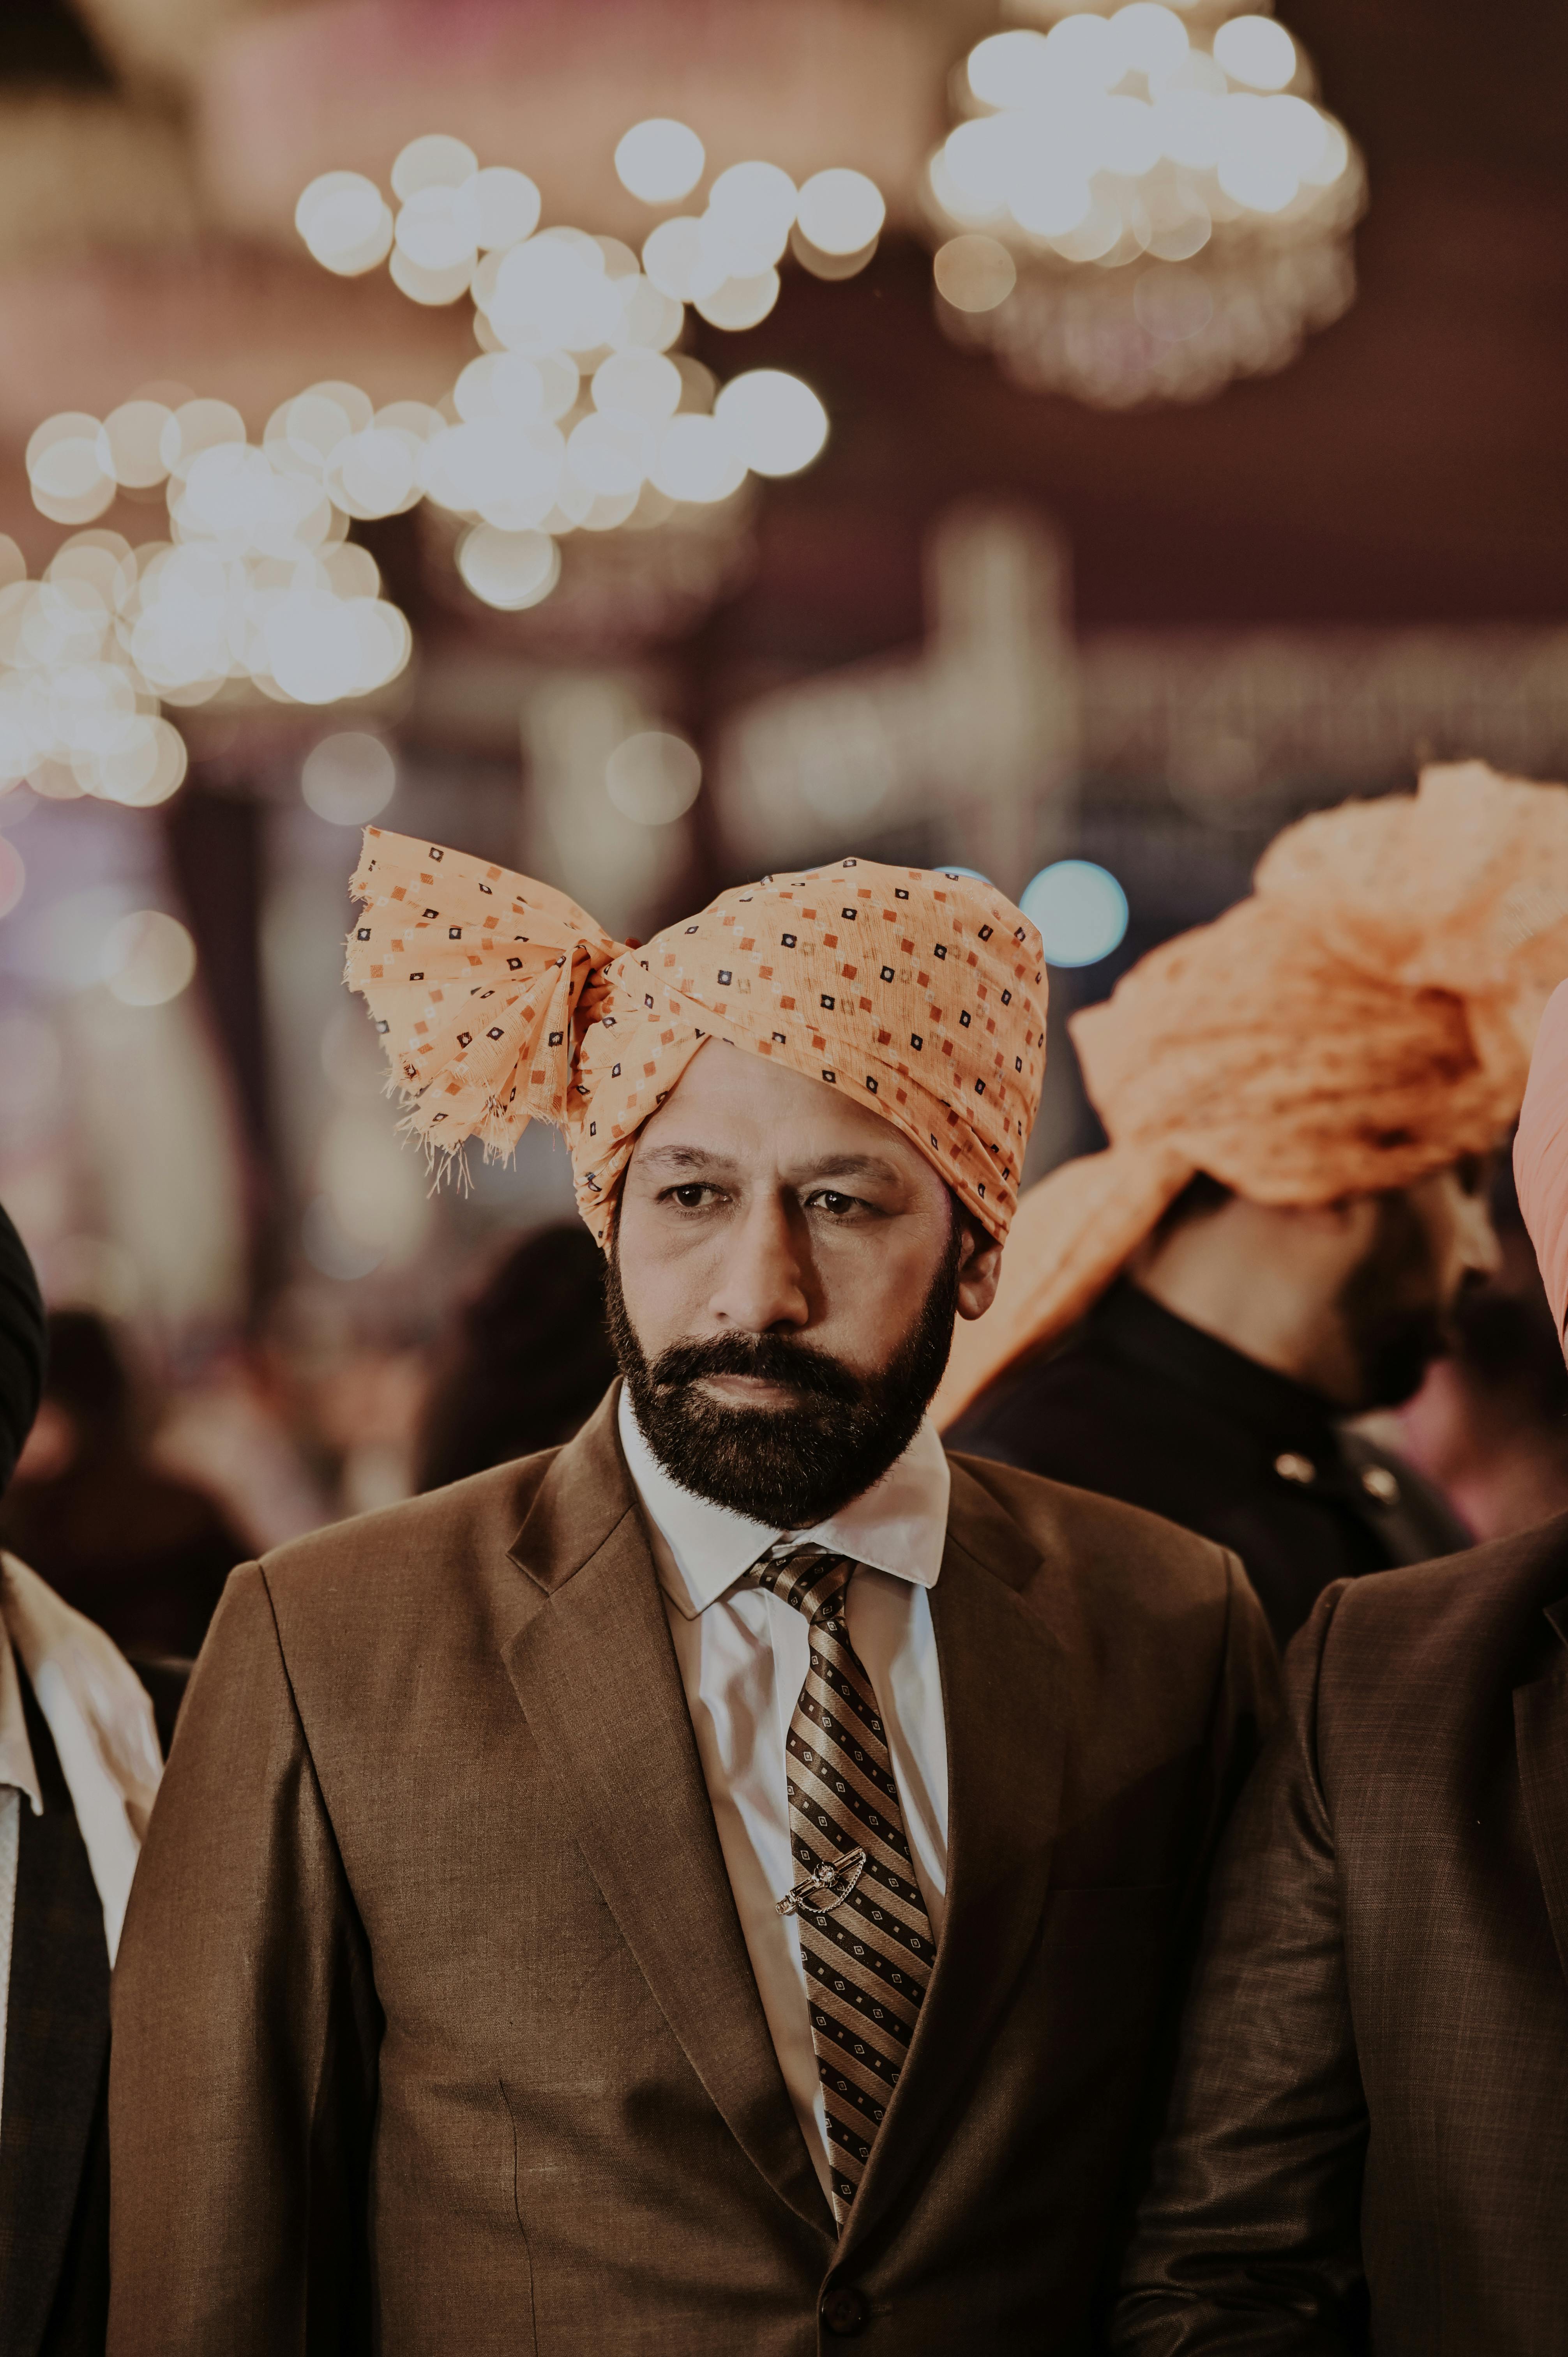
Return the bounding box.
[0,1678,108,2357]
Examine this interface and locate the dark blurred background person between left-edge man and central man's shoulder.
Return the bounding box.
[0,1311,250,1664]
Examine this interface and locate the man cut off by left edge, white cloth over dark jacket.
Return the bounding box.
[0,1212,160,2357]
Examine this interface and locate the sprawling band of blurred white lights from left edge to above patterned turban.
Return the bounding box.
[0,120,858,806]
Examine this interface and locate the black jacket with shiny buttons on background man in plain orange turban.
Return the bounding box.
[946,1282,1471,1645]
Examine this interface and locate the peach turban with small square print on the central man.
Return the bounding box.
[344,827,1045,1244]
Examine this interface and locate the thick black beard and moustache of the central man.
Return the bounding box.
[606,1219,964,1530]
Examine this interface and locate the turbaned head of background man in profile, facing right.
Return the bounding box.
[938,762,1568,1419]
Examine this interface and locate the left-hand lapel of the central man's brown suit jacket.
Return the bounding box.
[502,1393,832,2237]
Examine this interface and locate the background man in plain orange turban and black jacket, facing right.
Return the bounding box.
[936,764,1568,1645]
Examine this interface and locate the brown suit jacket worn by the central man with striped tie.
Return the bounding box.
[108,1393,1273,2357]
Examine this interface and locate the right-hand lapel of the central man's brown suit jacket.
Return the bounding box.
[842,1464,1066,2256]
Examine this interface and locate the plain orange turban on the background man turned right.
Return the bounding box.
[936,762,1568,1421]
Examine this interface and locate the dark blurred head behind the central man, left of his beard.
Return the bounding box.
[417,1219,615,1489]
